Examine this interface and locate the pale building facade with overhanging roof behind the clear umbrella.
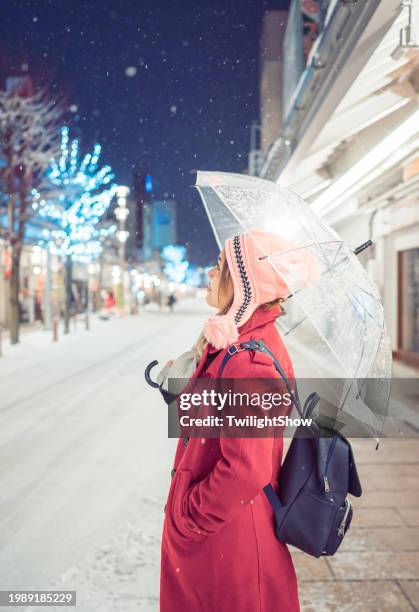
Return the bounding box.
[260,0,419,366]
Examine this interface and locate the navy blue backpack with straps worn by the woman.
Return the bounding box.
[219,340,362,557]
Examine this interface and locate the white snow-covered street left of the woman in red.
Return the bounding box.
[0,300,209,612]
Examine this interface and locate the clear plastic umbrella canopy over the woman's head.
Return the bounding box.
[195,171,392,438]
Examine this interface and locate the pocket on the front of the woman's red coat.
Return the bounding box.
[170,469,206,542]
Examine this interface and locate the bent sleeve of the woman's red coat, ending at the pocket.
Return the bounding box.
[172,352,286,541]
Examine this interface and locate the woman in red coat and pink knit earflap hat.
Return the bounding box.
[160,231,316,612]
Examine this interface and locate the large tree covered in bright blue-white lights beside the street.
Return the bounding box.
[36,126,117,333]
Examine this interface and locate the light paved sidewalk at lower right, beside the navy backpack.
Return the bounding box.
[289,439,419,612]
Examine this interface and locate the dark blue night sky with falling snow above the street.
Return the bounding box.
[0,0,288,264]
